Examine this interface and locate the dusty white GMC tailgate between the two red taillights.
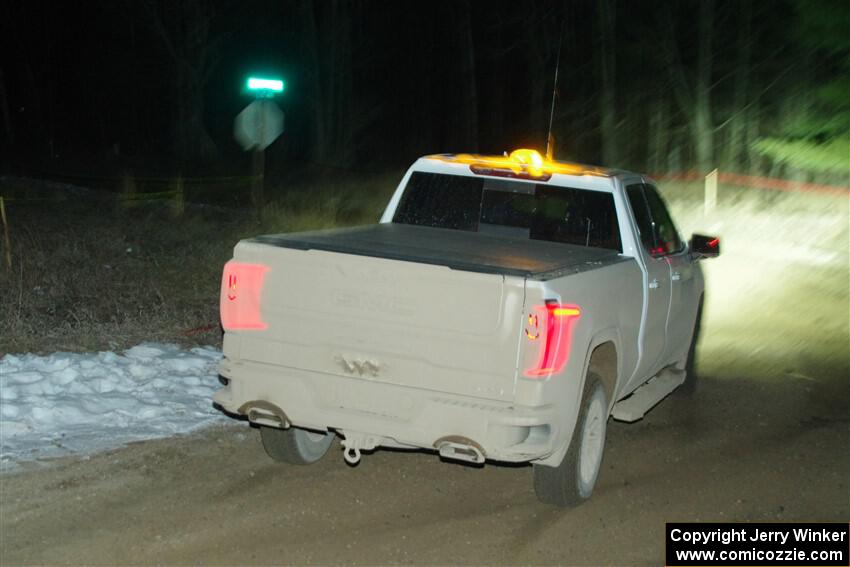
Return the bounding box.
[234,241,524,401]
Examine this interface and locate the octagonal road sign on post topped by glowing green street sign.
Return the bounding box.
[233,77,284,215]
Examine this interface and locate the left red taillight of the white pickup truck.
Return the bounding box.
[219,260,269,331]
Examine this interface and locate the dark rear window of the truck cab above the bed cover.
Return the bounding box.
[393,171,623,252]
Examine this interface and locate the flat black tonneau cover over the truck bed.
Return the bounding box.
[251,223,626,280]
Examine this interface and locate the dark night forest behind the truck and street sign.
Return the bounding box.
[0,0,850,184]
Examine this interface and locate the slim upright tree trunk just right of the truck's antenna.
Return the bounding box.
[597,0,619,166]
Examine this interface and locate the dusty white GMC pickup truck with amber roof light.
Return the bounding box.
[215,150,720,506]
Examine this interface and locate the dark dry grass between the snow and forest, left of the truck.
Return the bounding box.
[0,176,398,356]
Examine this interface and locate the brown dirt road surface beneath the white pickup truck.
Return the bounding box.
[0,350,850,566]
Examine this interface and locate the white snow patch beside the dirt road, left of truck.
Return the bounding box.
[0,343,227,469]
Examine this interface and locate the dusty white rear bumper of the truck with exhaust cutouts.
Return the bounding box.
[214,358,558,462]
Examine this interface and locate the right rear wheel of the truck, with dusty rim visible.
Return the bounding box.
[534,372,608,507]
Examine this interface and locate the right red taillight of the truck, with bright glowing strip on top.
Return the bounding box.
[524,301,581,378]
